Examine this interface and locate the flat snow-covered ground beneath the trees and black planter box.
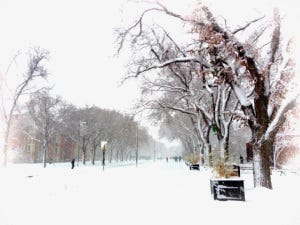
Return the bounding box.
[0,161,300,225]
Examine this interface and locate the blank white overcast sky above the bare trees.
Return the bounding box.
[0,0,299,142]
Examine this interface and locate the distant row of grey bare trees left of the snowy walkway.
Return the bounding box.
[11,89,154,167]
